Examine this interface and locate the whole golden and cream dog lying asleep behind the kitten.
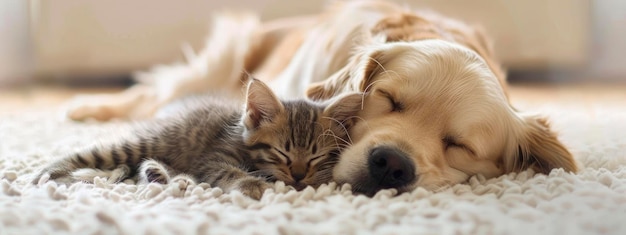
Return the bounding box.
[64,1,577,194]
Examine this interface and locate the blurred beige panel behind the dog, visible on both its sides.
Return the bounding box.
[0,0,608,83]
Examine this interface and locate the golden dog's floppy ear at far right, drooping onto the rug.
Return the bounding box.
[505,116,578,174]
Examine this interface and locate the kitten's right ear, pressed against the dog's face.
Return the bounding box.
[324,92,363,126]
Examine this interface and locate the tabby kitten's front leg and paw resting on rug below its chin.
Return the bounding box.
[203,163,272,200]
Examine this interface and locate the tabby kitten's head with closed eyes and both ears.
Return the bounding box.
[242,79,362,189]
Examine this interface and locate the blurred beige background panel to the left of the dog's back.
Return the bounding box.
[31,0,321,80]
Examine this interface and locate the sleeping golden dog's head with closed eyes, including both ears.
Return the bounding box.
[307,39,576,194]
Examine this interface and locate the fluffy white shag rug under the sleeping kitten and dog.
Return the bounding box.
[0,89,626,235]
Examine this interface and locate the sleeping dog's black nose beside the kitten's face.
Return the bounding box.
[368,147,415,188]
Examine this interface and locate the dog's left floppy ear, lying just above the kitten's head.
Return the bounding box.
[306,49,384,101]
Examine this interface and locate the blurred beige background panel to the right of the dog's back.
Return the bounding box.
[404,0,590,69]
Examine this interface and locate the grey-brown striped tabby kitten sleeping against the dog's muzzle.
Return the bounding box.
[33,79,362,199]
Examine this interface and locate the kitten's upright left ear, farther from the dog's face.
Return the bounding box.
[243,78,284,129]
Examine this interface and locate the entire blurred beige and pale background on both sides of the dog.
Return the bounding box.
[0,0,626,87]
